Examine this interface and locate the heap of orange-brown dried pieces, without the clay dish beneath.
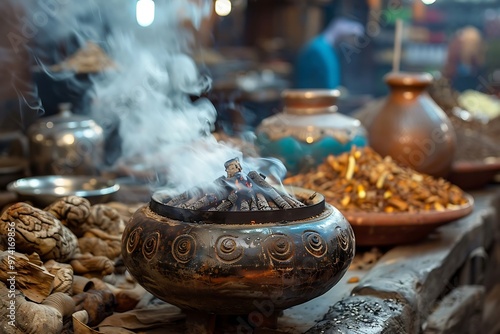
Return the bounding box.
[283,147,467,213]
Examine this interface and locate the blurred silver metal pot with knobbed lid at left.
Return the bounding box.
[27,103,104,175]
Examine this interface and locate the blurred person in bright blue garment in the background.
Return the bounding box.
[295,17,365,89]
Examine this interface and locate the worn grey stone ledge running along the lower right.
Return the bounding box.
[307,189,500,334]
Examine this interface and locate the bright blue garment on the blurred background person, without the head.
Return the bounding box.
[295,35,340,89]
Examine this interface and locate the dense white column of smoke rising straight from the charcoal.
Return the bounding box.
[86,0,246,191]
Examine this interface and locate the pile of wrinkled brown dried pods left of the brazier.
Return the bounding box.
[0,196,155,334]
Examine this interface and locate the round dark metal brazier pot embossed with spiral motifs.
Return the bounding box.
[122,174,355,330]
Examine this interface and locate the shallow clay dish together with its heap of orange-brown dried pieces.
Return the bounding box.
[284,147,474,246]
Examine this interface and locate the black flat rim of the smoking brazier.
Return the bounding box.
[149,187,325,224]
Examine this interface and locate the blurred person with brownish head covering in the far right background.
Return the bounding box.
[443,26,485,92]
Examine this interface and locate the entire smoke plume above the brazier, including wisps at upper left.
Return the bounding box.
[1,0,283,191]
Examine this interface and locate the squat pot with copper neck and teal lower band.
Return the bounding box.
[256,89,368,173]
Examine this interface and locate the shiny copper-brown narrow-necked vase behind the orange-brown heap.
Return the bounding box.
[368,72,456,177]
